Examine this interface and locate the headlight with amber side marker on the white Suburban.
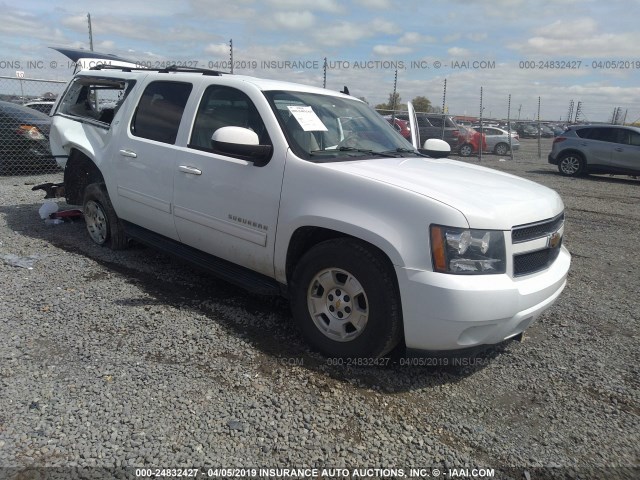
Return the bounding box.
[431,225,506,275]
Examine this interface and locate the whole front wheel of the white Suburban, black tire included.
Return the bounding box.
[290,238,402,358]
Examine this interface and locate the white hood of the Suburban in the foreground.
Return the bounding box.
[325,158,564,230]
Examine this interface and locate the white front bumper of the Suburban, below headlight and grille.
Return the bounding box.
[396,247,571,351]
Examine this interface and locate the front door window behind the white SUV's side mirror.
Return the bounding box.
[189,85,271,150]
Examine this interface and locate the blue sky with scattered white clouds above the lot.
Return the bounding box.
[0,0,640,121]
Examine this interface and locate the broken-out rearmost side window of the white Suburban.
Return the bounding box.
[56,76,135,125]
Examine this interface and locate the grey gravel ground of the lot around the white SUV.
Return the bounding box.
[0,140,640,479]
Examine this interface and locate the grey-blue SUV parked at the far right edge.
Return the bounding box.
[548,125,640,176]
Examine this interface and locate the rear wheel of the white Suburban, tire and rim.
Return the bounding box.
[82,183,127,250]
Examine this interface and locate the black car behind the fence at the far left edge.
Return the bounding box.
[0,101,57,174]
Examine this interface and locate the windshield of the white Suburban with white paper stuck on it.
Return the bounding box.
[264,91,415,162]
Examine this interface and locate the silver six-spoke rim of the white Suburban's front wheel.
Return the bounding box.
[307,268,370,342]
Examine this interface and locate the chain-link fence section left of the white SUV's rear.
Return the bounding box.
[0,76,67,175]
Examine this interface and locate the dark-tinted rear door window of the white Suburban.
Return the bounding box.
[131,81,193,143]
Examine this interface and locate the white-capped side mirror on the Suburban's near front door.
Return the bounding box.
[211,127,273,167]
